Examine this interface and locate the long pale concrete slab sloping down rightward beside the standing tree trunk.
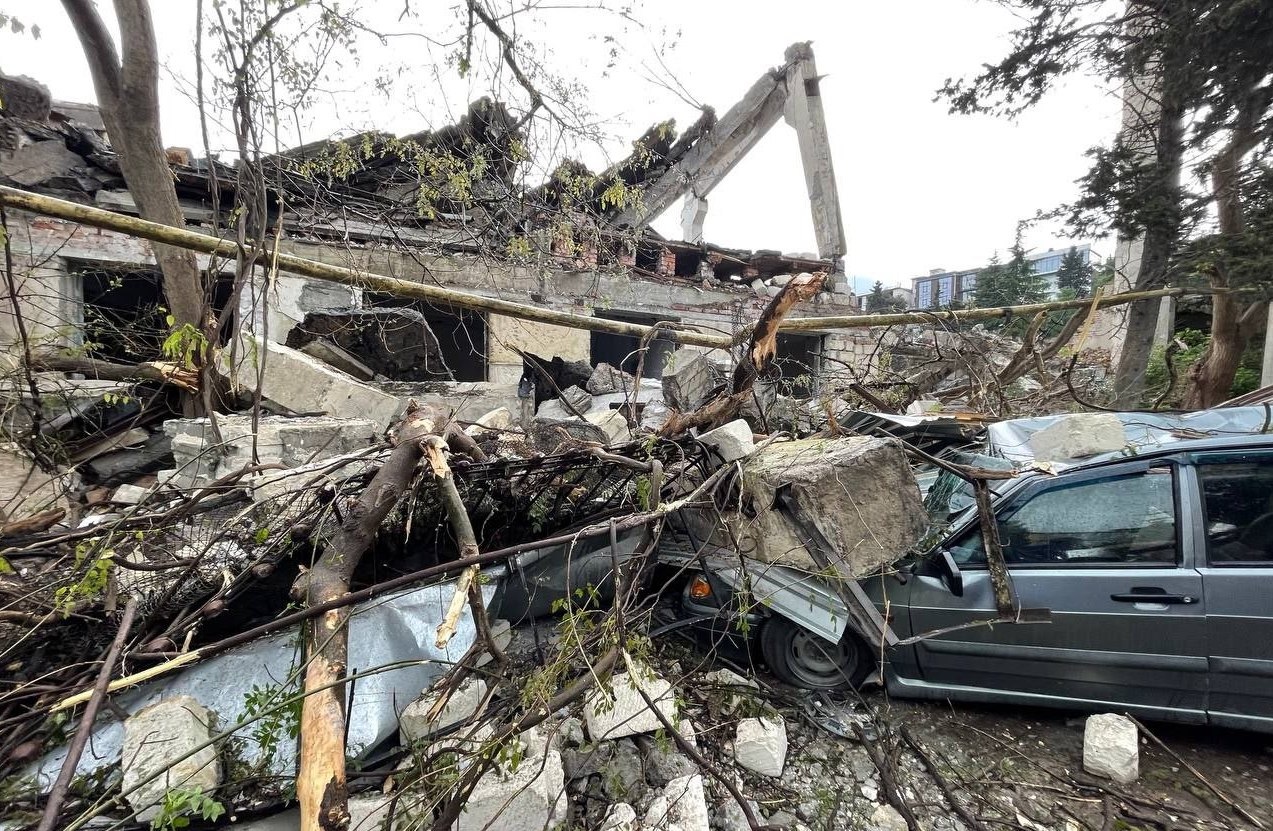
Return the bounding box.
[222,337,406,430]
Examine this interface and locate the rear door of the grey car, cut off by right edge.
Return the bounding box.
[1194,450,1273,730]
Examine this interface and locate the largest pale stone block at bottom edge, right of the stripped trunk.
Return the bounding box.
[453,730,566,831]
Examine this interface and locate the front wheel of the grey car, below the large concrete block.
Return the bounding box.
[760,615,871,690]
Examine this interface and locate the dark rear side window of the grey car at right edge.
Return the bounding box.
[1198,453,1273,565]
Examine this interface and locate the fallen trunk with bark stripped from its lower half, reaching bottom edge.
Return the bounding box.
[292,407,447,831]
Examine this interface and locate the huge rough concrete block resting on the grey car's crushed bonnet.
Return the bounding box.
[726,436,928,579]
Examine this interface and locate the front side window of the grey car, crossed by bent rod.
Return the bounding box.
[950,468,1180,566]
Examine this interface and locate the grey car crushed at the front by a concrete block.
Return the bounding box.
[682,435,1273,732]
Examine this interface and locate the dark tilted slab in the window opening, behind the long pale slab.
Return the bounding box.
[288,308,453,381]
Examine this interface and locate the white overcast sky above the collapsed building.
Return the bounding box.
[0,0,1119,285]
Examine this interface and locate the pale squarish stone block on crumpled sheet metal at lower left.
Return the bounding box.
[122,695,222,822]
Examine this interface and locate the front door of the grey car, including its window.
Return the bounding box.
[909,462,1207,722]
